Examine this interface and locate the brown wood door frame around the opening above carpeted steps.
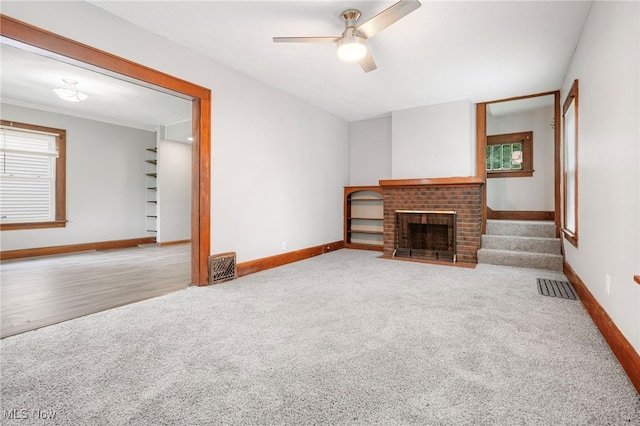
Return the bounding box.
[476,90,561,237]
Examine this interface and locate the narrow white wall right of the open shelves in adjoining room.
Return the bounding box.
[157,140,192,243]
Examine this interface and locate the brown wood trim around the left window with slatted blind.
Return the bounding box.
[0,120,67,231]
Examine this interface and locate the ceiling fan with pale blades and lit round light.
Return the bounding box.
[273,0,421,72]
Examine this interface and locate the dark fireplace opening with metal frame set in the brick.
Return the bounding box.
[393,210,456,262]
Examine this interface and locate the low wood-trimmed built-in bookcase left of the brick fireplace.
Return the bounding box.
[344,186,384,251]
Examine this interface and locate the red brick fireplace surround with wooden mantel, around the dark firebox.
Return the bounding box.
[380,177,483,265]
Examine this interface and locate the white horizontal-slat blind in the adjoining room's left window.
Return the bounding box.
[0,127,58,223]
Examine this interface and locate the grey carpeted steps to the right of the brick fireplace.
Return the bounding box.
[478,220,563,271]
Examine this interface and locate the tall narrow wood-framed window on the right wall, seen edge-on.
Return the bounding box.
[562,80,578,247]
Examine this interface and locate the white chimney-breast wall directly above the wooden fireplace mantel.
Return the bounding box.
[392,100,476,179]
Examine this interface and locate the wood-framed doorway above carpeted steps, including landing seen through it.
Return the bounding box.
[476,91,560,236]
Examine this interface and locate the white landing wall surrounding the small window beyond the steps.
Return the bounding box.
[487,107,555,211]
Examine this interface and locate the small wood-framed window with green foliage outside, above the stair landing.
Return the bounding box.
[486,132,533,177]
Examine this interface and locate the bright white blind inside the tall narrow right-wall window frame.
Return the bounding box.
[564,101,577,234]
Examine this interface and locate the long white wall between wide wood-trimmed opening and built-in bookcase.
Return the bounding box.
[2,1,349,262]
